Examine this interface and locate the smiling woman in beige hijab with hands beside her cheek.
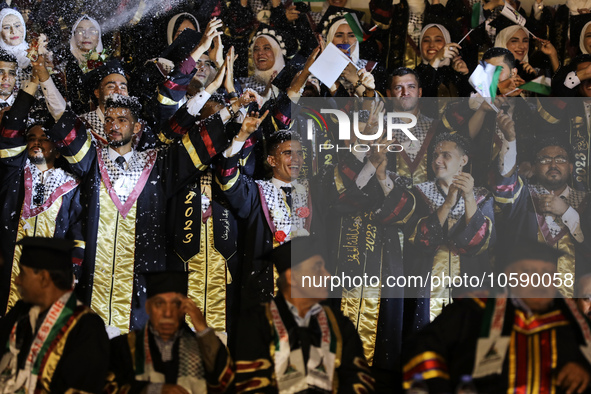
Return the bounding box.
[415,23,472,97]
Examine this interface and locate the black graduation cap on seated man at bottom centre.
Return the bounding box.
[263,236,326,274]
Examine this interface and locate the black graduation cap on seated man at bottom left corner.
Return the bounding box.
[16,237,76,270]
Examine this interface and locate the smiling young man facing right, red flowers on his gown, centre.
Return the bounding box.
[216,130,312,308]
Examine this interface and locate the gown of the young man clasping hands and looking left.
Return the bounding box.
[405,181,496,327]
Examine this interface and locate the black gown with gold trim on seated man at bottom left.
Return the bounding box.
[0,294,109,393]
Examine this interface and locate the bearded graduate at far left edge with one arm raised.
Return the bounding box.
[0,75,84,316]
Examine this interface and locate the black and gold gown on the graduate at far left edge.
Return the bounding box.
[0,91,84,316]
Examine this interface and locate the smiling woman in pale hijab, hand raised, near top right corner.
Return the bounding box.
[495,25,560,80]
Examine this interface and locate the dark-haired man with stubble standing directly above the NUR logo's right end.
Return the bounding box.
[386,67,437,186]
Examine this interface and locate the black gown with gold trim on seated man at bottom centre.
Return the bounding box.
[234,293,373,393]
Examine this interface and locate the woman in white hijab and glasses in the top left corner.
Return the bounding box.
[0,8,31,87]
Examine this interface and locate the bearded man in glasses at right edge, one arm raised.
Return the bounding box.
[493,115,591,297]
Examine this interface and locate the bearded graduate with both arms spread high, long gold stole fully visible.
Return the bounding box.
[44,63,238,332]
